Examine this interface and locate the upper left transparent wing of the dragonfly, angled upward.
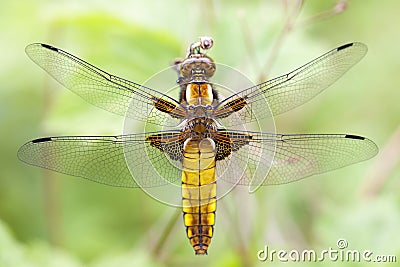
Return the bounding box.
[25,44,184,126]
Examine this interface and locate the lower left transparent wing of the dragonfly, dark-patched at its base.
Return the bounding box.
[18,131,182,187]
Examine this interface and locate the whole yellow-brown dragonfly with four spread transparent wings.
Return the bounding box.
[18,37,378,255]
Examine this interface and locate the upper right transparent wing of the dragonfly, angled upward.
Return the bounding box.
[215,43,367,127]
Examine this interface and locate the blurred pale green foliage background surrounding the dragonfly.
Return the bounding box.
[0,0,400,267]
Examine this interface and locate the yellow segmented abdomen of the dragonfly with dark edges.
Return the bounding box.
[182,138,217,254]
